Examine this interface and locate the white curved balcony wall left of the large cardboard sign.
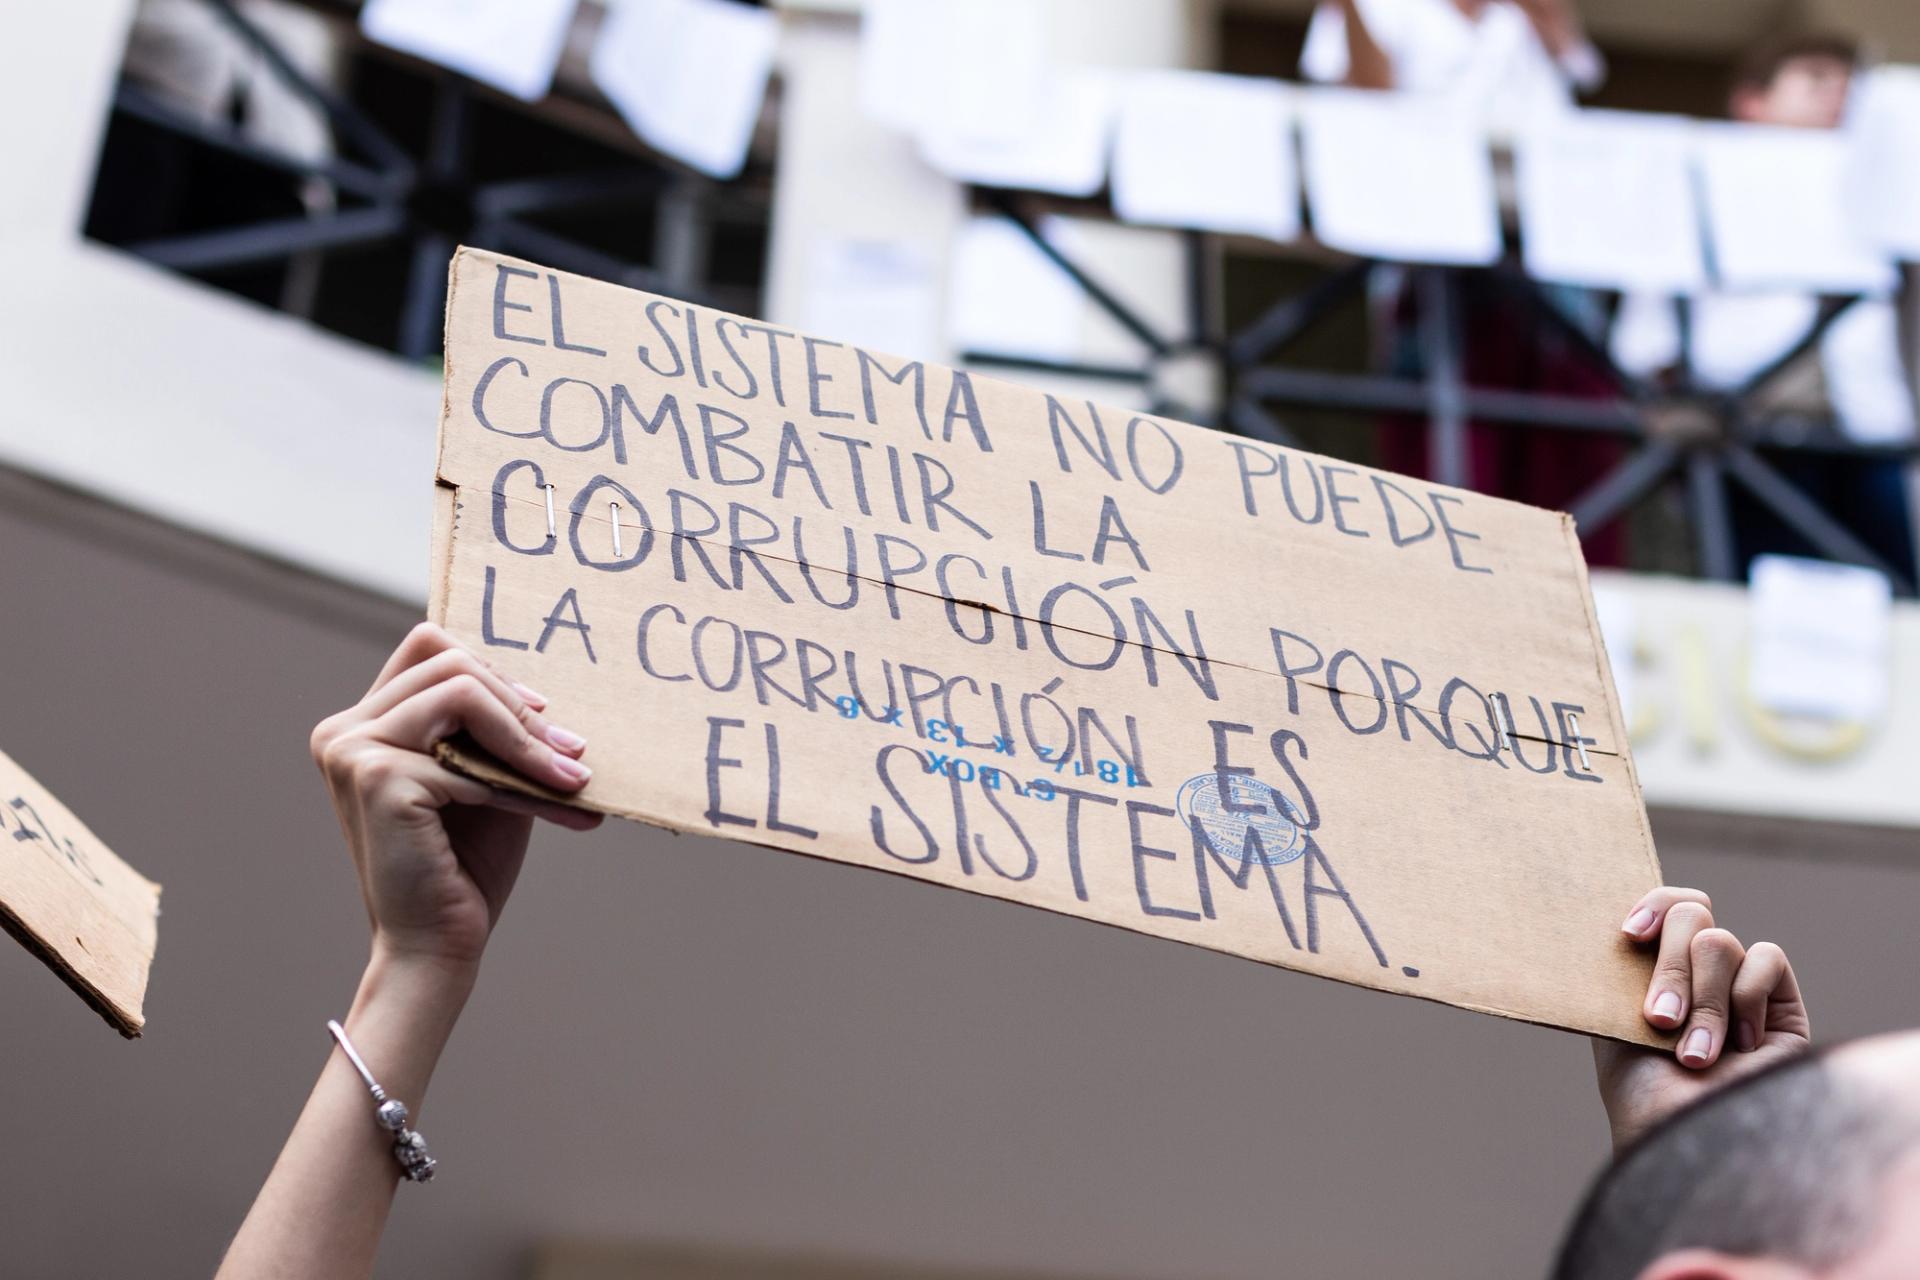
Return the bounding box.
[0,0,440,601]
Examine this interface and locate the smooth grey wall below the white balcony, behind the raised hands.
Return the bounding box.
[0,466,1920,1280]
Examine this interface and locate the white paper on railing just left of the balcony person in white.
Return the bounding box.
[1112,71,1300,240]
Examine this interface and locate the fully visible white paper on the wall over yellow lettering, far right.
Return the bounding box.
[1749,555,1893,722]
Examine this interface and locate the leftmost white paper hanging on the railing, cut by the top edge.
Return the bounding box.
[361,0,578,102]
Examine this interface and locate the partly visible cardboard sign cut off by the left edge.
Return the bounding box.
[0,754,159,1038]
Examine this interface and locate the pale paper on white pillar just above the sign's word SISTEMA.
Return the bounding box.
[803,240,945,361]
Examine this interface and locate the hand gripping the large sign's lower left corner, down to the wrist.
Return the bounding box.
[311,622,601,969]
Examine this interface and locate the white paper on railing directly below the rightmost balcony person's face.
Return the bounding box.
[1695,125,1893,294]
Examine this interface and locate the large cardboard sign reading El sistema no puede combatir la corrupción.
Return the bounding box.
[432,249,1661,1042]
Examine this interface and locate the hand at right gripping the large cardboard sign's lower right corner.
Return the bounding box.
[1594,887,1812,1150]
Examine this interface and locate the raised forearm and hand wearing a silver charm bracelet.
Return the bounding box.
[219,624,599,1280]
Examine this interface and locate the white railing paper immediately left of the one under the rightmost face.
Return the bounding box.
[1513,111,1707,294]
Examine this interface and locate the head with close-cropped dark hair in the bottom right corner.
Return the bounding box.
[1553,1032,1920,1280]
